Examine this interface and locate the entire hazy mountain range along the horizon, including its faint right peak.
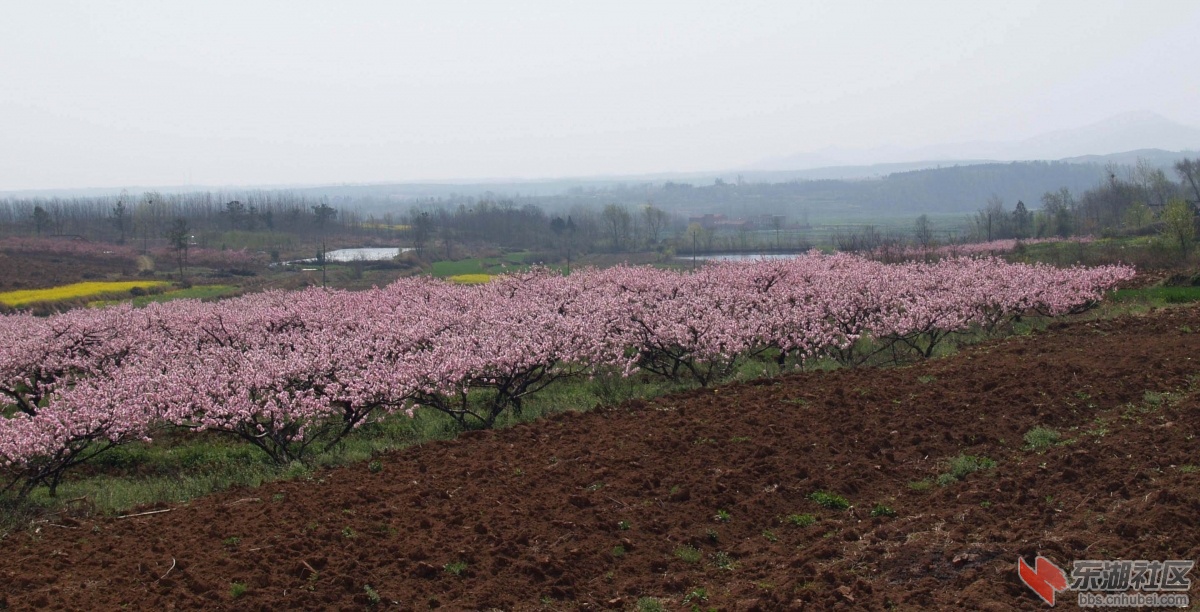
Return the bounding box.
[0,112,1200,201]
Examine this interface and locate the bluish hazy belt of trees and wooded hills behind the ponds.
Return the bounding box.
[0,154,1200,259]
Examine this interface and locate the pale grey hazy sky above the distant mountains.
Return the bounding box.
[0,0,1200,190]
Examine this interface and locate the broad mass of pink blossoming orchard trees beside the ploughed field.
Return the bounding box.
[0,252,1133,487]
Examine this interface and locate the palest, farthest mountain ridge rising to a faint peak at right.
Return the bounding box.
[744,110,1200,172]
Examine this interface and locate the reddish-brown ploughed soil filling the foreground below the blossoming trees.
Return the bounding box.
[0,308,1200,610]
